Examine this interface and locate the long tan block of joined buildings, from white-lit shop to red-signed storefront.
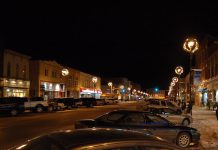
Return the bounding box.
[30,60,101,99]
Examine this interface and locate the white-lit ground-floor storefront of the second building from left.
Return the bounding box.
[40,82,65,99]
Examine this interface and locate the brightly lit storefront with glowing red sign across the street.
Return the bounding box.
[79,88,102,99]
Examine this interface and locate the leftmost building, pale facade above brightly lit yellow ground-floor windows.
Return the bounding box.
[0,49,30,97]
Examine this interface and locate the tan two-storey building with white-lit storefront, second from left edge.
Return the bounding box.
[30,60,66,99]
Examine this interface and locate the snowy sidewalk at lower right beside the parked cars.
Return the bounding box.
[191,106,218,150]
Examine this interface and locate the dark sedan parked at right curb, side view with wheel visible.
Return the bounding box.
[75,110,200,147]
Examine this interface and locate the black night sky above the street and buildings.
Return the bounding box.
[0,0,218,89]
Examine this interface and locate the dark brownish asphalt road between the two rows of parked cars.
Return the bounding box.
[0,103,135,150]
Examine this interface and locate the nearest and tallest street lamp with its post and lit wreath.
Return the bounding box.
[183,38,199,104]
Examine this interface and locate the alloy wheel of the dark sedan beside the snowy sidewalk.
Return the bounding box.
[176,132,191,148]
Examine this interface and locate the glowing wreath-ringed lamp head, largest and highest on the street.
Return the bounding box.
[183,38,199,53]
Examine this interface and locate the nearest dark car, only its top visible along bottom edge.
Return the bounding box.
[11,128,181,150]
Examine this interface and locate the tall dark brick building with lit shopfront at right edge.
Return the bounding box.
[195,36,218,105]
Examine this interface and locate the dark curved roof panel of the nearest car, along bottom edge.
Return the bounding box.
[11,128,168,149]
